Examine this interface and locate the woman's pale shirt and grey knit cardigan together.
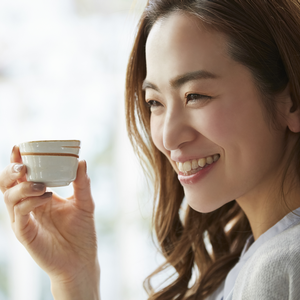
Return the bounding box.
[206,207,300,300]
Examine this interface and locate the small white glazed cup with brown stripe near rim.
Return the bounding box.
[19,140,80,187]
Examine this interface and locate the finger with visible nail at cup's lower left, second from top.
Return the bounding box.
[0,163,26,193]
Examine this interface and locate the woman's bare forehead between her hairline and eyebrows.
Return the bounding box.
[146,12,233,81]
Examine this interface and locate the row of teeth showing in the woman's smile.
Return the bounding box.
[176,154,220,176]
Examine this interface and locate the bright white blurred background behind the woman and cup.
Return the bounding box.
[0,0,168,300]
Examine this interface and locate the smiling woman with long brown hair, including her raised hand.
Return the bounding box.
[0,0,300,300]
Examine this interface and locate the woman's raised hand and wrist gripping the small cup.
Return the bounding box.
[0,146,100,300]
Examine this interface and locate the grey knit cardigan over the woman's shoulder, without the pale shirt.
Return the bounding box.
[233,224,300,300]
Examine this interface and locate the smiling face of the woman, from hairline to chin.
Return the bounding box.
[143,13,286,212]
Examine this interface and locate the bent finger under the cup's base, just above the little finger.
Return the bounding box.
[4,182,46,223]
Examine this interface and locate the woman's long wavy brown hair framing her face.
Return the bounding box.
[126,0,300,300]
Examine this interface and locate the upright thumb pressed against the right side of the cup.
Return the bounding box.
[73,160,95,212]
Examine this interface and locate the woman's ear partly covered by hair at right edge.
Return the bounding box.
[280,84,300,133]
